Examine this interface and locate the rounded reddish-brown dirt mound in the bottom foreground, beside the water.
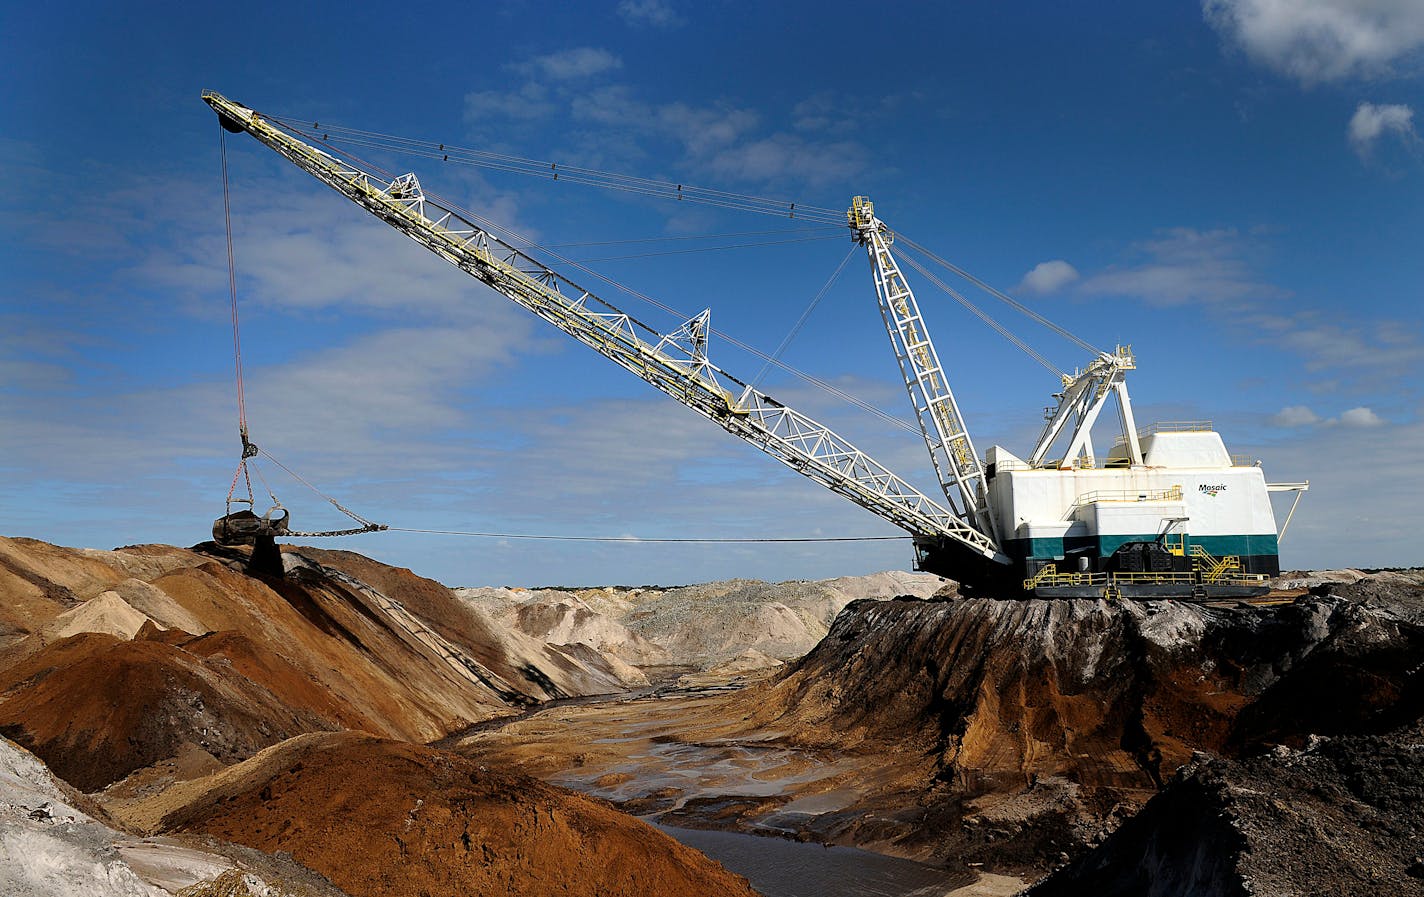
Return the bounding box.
[147,733,753,897]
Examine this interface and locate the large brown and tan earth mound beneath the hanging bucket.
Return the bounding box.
[0,538,641,789]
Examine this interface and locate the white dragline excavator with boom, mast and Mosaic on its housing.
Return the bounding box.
[202,91,1307,598]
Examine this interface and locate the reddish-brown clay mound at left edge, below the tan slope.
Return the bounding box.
[0,624,343,792]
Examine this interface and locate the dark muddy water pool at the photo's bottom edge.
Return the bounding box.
[658,826,964,897]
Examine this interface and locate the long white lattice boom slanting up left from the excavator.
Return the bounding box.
[202,91,1010,564]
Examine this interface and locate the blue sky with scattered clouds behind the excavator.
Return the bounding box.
[0,0,1424,585]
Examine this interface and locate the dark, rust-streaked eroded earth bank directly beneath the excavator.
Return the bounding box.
[742,574,1424,870]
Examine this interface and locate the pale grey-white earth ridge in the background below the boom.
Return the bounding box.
[456,571,946,669]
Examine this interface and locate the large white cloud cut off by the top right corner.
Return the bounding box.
[1202,0,1424,85]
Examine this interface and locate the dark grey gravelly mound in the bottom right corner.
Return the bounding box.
[1028,726,1424,897]
